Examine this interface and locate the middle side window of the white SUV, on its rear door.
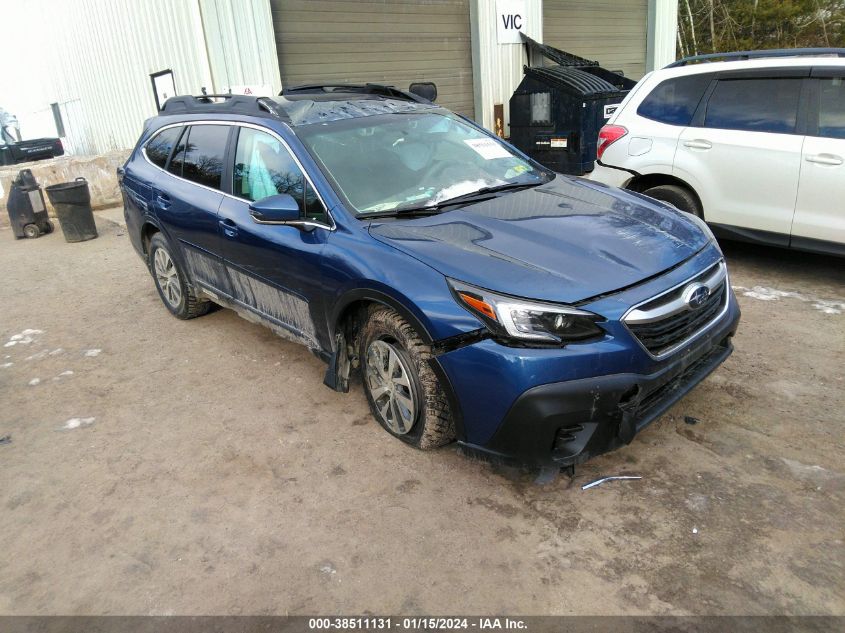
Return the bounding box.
[704,78,801,134]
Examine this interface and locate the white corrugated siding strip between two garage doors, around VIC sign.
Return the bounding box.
[472,0,543,136]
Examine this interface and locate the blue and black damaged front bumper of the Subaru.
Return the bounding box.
[438,284,740,468]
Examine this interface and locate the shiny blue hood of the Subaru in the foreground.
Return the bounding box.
[370,176,709,303]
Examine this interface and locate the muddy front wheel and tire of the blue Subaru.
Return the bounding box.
[358,306,455,450]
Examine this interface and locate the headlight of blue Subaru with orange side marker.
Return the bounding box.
[449,279,604,344]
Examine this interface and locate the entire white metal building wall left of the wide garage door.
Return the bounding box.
[4,0,280,154]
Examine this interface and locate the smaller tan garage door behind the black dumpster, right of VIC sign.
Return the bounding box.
[543,0,648,79]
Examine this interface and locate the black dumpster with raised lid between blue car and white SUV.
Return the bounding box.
[509,35,636,176]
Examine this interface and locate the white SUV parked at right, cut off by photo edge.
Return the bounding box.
[587,49,845,255]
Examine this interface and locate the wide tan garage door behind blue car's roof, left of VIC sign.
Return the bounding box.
[270,0,473,117]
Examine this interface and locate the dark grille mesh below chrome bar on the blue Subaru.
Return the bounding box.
[628,279,728,356]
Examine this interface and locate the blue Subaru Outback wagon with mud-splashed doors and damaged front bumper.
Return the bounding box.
[118,85,739,471]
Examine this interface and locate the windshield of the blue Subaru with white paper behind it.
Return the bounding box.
[297,111,550,215]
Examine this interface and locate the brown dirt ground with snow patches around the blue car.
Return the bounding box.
[0,213,845,615]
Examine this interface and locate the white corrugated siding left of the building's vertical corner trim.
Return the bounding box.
[28,0,211,153]
